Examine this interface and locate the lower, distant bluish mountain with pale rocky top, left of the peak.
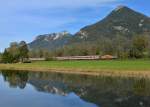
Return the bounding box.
[28,31,72,50]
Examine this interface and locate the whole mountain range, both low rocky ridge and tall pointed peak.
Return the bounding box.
[29,6,150,50]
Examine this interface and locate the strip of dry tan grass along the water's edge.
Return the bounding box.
[0,65,150,78]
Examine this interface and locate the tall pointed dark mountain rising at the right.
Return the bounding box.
[73,6,150,41]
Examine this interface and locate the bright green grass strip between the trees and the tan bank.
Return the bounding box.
[2,60,150,70]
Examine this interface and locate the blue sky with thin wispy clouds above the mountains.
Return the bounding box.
[0,0,150,52]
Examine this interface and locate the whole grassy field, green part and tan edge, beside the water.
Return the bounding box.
[0,59,150,76]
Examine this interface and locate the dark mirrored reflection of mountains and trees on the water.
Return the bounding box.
[1,71,150,107]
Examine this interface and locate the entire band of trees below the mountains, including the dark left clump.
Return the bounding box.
[1,34,150,63]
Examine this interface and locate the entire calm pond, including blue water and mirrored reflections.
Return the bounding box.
[0,71,150,107]
